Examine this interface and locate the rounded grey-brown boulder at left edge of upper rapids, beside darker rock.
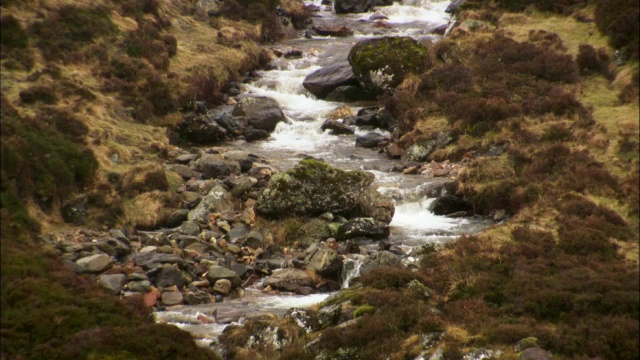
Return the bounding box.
[232,96,286,132]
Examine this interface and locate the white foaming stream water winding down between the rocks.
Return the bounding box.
[155,0,491,346]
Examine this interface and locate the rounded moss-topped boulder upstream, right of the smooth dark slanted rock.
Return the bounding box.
[348,37,429,94]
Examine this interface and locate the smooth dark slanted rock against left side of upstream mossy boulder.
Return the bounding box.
[302,61,360,99]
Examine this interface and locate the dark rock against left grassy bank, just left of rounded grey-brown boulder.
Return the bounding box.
[177,114,228,144]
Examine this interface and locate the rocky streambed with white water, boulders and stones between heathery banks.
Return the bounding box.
[45,1,492,356]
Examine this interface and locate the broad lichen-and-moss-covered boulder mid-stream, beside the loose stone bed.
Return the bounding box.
[256,160,374,216]
